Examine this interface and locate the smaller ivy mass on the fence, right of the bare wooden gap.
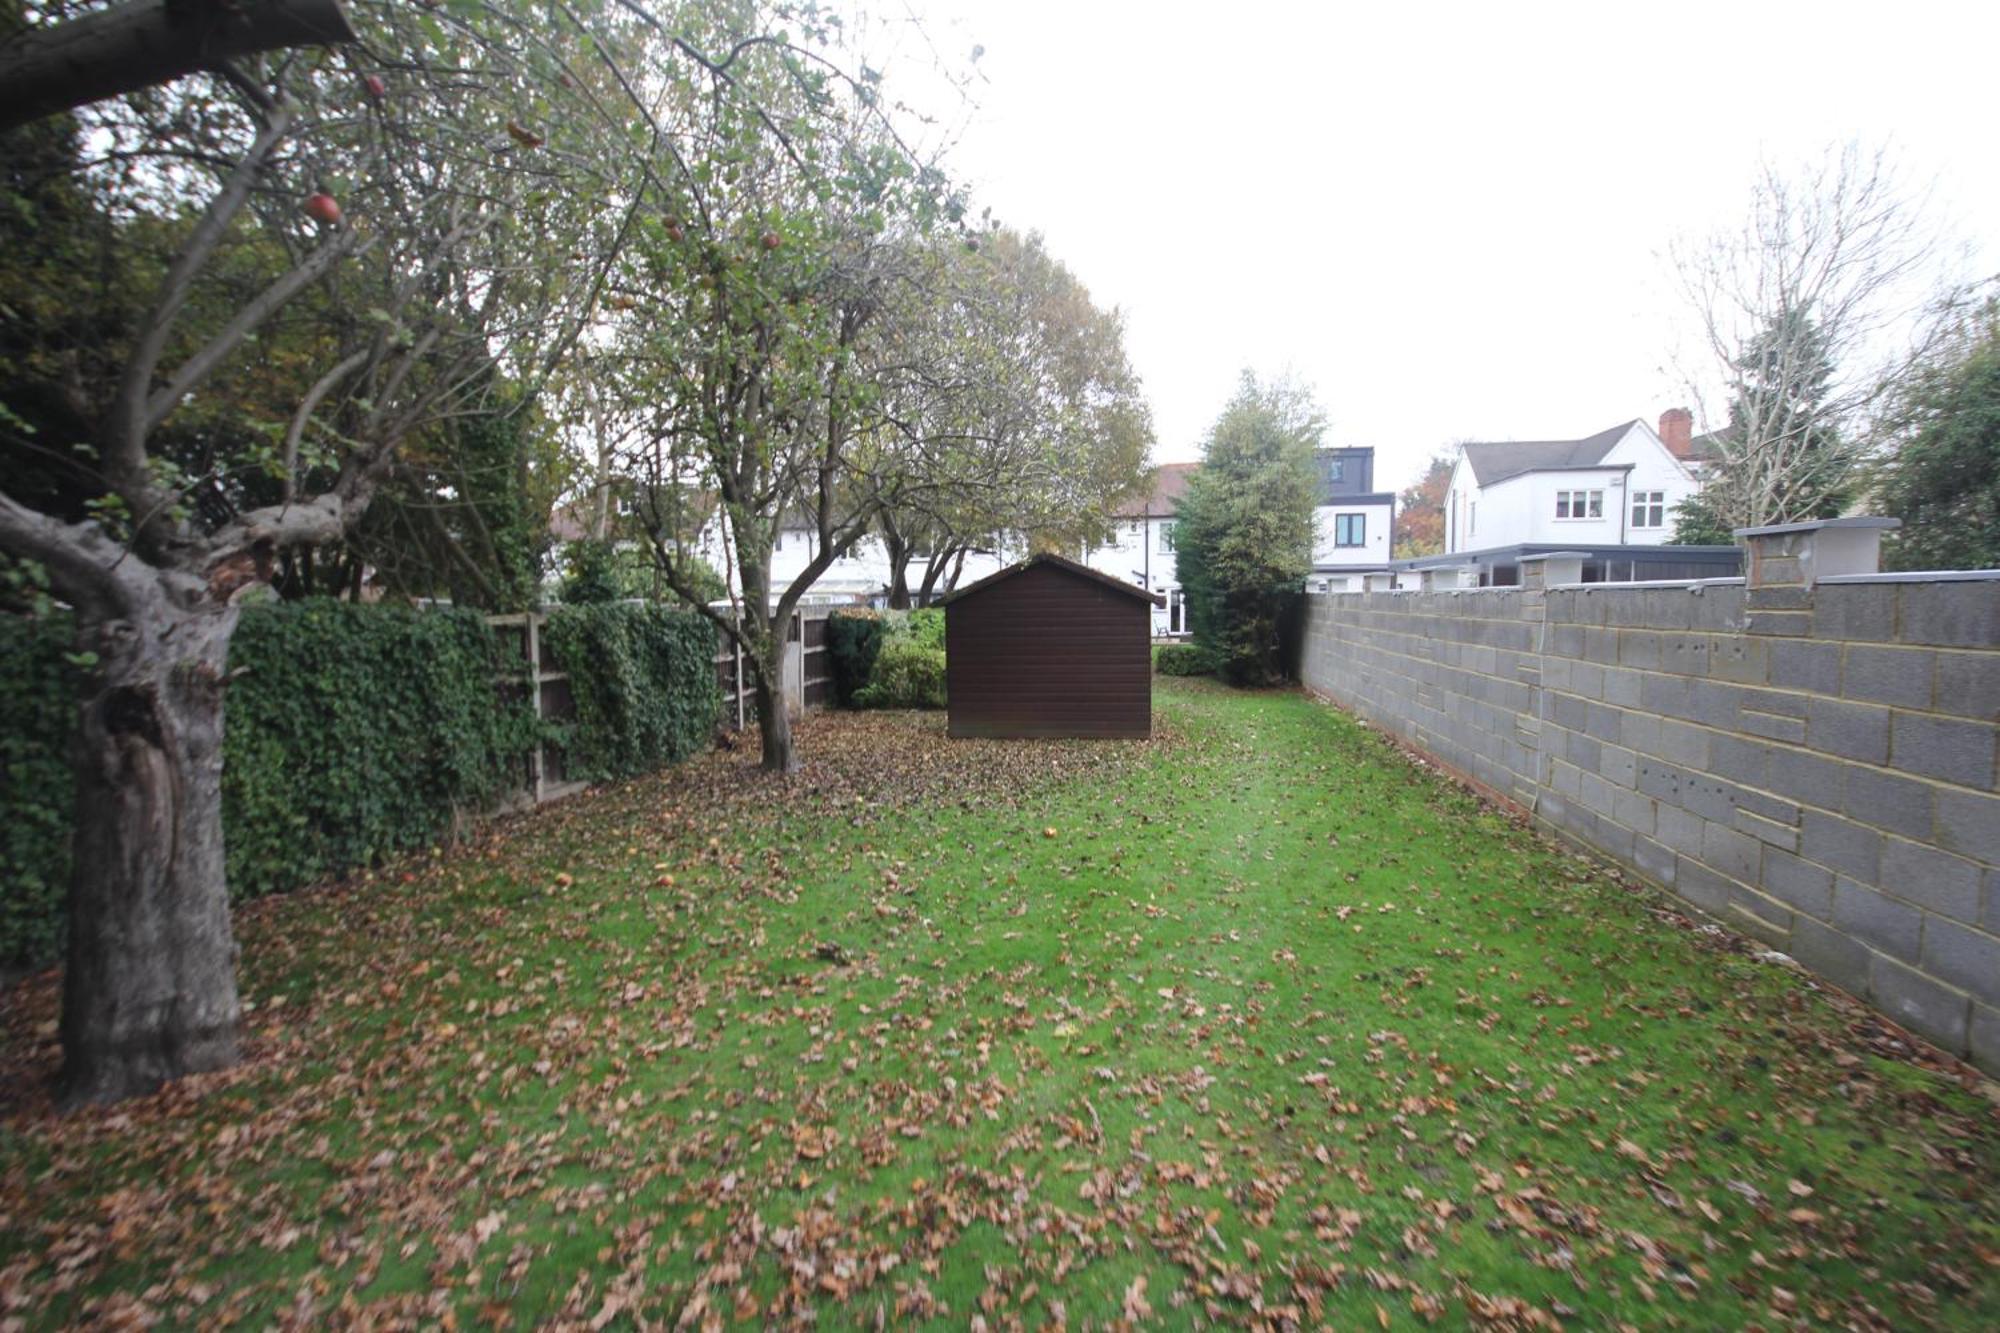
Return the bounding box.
[542,602,722,779]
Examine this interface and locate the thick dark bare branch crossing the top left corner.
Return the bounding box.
[0,0,354,132]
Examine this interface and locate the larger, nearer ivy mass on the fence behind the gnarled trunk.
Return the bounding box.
[0,600,536,967]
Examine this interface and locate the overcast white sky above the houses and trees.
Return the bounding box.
[890,0,2000,488]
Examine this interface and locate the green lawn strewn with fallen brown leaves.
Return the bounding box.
[0,681,2000,1329]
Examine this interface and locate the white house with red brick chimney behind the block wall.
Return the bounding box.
[1444,408,1704,552]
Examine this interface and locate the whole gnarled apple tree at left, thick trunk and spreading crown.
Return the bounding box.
[0,0,852,1101]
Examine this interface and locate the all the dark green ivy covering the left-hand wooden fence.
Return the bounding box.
[0,600,718,971]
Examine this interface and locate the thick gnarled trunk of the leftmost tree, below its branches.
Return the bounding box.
[62,592,240,1103]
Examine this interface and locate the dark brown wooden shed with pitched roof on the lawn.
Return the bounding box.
[944,554,1166,737]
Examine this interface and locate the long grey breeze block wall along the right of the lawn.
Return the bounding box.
[1302,534,2000,1073]
